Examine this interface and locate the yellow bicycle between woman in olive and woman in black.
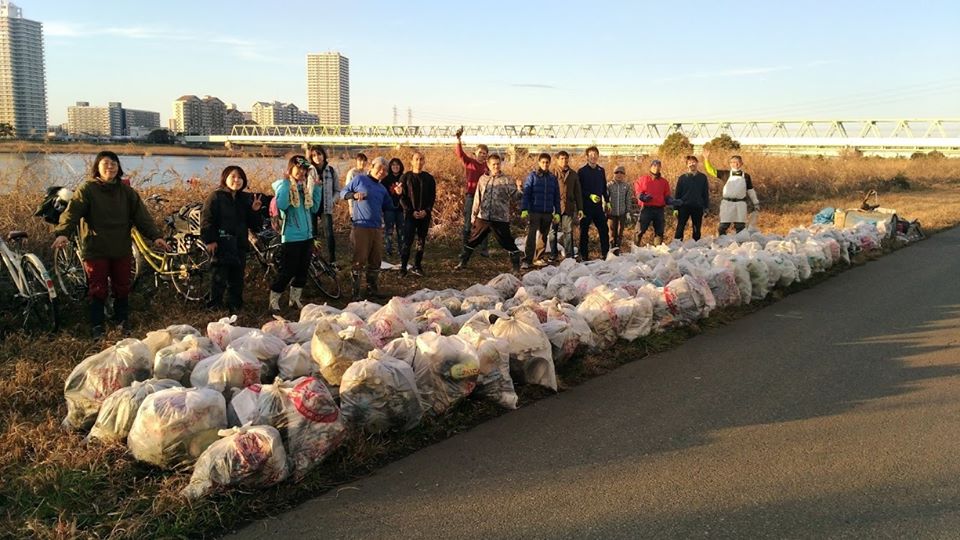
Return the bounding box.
[130,229,211,301]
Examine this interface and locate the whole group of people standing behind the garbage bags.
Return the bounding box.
[53,142,759,336]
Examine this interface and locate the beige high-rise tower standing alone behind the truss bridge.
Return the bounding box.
[307,52,350,126]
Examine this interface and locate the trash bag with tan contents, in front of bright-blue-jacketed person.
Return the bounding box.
[310,320,379,386]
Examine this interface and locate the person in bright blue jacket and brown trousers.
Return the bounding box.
[340,157,396,300]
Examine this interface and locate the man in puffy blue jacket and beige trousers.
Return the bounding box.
[520,153,560,270]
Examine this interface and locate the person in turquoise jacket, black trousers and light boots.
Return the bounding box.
[270,156,322,311]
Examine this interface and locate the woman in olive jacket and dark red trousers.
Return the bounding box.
[53,151,170,339]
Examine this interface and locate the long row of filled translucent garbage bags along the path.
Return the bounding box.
[63,223,881,499]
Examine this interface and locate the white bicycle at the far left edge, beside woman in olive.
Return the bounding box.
[0,231,60,331]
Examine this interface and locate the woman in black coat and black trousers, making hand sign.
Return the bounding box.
[200,165,263,310]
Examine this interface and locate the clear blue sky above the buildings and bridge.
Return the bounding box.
[26,0,960,125]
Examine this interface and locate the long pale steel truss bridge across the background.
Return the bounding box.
[185,119,960,156]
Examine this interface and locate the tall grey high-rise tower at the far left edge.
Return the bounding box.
[0,0,47,137]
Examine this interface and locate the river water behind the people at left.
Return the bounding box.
[0,154,352,193]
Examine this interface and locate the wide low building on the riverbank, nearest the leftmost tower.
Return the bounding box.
[67,101,160,137]
